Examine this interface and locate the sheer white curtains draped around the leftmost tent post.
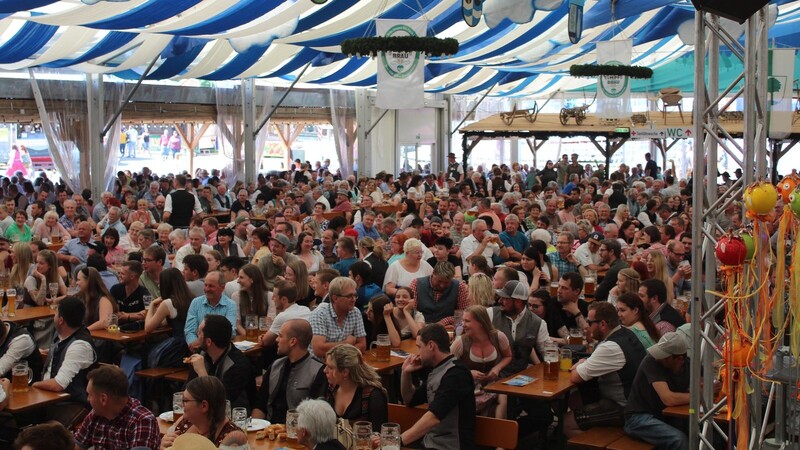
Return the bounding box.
[30,69,124,195]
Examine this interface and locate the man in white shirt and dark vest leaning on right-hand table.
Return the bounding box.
[564,302,646,438]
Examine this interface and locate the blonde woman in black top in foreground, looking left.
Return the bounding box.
[325,344,389,431]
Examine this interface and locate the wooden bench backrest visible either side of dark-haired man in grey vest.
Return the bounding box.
[389,403,519,449]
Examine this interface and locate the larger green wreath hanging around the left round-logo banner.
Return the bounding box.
[342,36,458,58]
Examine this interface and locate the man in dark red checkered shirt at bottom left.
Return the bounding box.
[75,366,161,450]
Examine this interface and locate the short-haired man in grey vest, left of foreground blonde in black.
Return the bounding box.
[253,319,328,423]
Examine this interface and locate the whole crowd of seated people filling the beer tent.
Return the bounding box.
[0,154,741,449]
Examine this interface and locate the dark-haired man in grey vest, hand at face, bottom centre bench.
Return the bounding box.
[400,323,475,450]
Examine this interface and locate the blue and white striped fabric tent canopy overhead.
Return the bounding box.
[0,0,800,96]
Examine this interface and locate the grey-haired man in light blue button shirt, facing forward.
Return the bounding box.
[183,270,237,351]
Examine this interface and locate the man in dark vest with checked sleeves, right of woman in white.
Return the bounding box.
[409,261,470,326]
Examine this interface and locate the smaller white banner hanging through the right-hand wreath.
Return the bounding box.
[596,39,633,119]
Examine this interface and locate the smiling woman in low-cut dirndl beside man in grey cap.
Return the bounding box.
[450,305,511,419]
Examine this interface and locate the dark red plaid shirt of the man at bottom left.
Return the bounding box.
[75,397,161,450]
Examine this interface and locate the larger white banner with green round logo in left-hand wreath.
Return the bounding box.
[375,19,428,109]
